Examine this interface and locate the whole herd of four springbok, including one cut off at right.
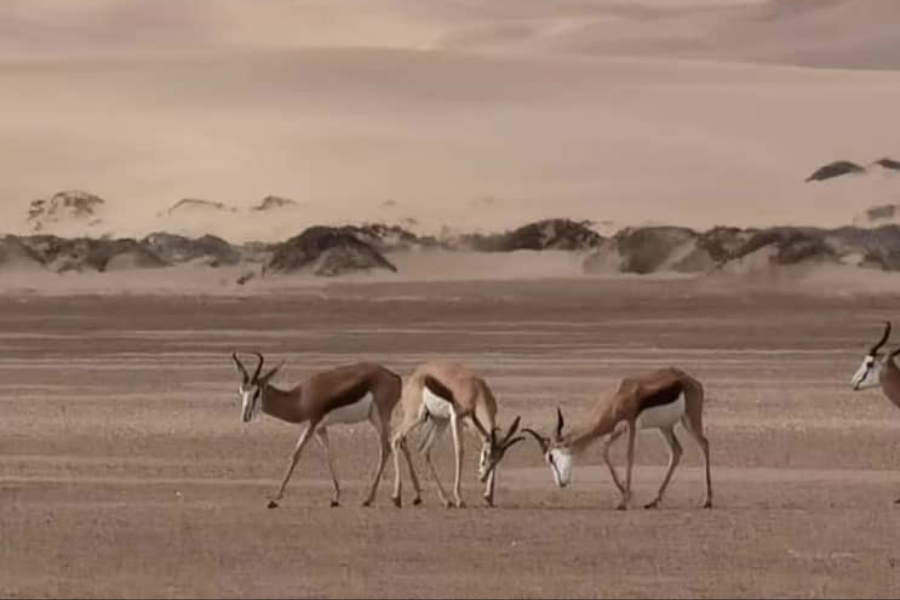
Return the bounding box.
[232,323,900,510]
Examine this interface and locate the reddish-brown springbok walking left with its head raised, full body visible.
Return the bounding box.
[231,353,409,508]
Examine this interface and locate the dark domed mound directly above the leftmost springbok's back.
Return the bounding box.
[264,227,397,277]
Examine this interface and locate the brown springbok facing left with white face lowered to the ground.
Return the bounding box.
[522,369,712,510]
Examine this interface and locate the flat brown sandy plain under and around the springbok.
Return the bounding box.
[0,280,900,598]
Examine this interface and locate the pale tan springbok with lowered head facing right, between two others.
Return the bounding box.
[393,361,524,508]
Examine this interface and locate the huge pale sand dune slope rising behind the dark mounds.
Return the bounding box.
[0,0,900,241]
